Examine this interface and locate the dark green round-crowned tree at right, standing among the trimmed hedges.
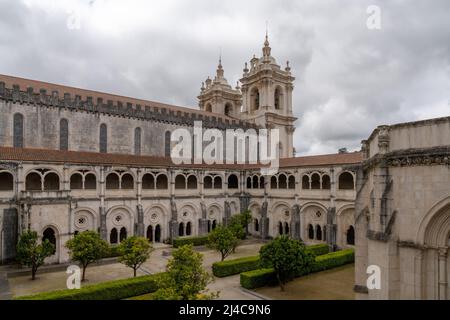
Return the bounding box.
[259,235,314,291]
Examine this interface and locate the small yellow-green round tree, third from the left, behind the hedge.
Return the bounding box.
[118,237,152,277]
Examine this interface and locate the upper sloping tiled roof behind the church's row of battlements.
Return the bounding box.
[0,74,234,121]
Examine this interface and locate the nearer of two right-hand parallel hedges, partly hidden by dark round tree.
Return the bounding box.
[240,249,355,289]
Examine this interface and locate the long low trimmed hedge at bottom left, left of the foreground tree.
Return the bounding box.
[14,273,161,300]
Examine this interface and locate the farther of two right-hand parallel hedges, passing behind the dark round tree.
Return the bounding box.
[212,244,329,278]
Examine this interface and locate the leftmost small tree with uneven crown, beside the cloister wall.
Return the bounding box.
[17,230,55,280]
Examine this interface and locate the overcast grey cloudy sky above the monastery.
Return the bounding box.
[0,0,450,155]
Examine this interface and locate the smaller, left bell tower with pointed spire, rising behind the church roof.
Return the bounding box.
[198,58,242,118]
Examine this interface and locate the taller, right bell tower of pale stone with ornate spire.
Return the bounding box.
[240,32,297,158]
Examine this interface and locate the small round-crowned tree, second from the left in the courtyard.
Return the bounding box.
[66,231,109,281]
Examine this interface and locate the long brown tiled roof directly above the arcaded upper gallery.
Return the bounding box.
[0,147,362,169]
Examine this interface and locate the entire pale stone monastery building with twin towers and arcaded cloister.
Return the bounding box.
[0,38,450,298]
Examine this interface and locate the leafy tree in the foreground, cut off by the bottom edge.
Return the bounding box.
[152,245,216,300]
